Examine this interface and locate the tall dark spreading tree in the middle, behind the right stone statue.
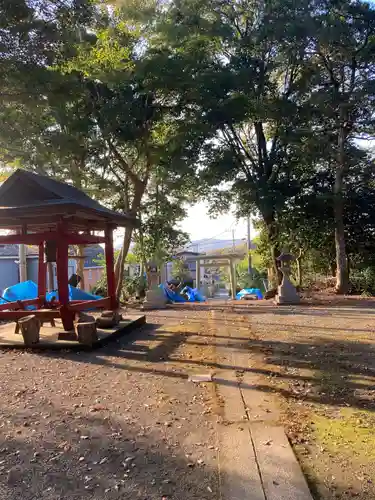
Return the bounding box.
[141,0,320,282]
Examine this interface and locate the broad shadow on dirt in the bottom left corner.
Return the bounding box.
[0,407,218,500]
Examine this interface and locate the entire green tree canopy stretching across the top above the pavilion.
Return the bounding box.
[0,0,375,292]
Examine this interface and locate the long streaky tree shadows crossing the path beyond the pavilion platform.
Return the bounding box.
[40,320,375,411]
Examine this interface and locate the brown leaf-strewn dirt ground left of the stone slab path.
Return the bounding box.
[0,313,219,500]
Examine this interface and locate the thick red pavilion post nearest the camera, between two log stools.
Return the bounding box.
[56,234,74,331]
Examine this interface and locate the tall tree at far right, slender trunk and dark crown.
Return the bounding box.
[307,0,375,293]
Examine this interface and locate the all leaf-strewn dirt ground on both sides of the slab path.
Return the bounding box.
[0,297,375,500]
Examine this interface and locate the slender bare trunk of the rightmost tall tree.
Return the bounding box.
[333,121,349,294]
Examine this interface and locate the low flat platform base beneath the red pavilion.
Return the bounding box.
[0,313,146,351]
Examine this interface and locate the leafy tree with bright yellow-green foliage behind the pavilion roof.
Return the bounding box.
[0,0,200,294]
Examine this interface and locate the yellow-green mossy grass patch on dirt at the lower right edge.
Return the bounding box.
[312,408,375,461]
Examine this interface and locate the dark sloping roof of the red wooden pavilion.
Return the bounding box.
[0,169,137,230]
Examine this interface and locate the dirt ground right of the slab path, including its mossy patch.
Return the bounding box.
[222,295,375,500]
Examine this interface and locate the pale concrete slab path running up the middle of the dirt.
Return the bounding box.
[211,311,312,500]
